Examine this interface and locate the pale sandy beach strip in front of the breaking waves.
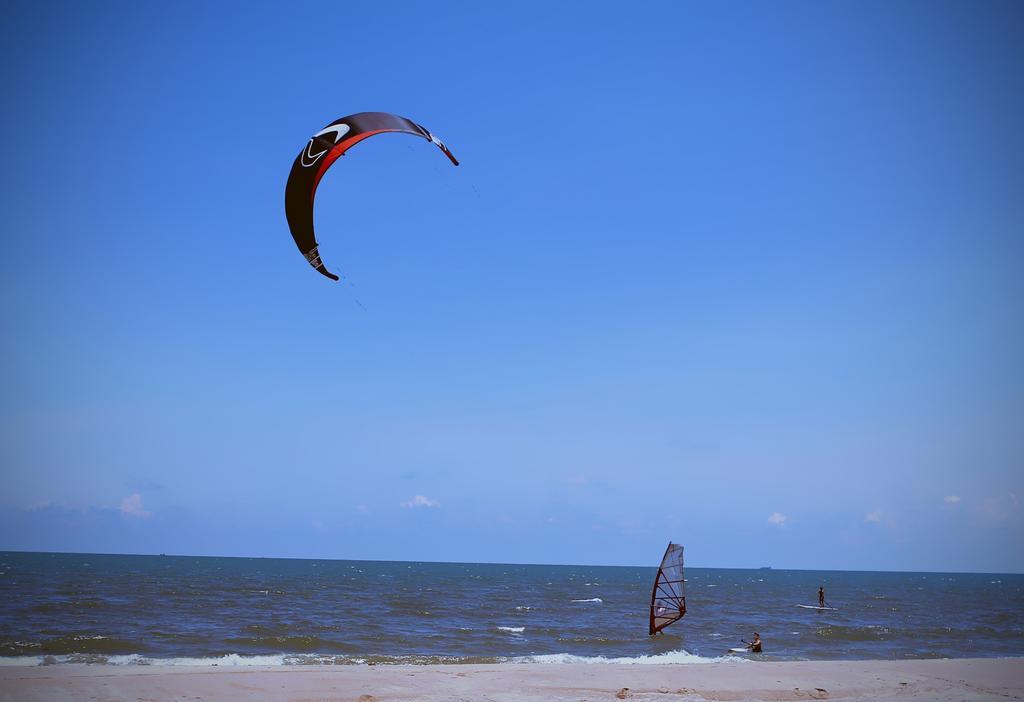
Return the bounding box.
[0,658,1024,702]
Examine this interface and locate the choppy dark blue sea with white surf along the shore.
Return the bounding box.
[0,553,1024,665]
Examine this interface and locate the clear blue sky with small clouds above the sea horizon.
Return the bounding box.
[0,2,1024,571]
